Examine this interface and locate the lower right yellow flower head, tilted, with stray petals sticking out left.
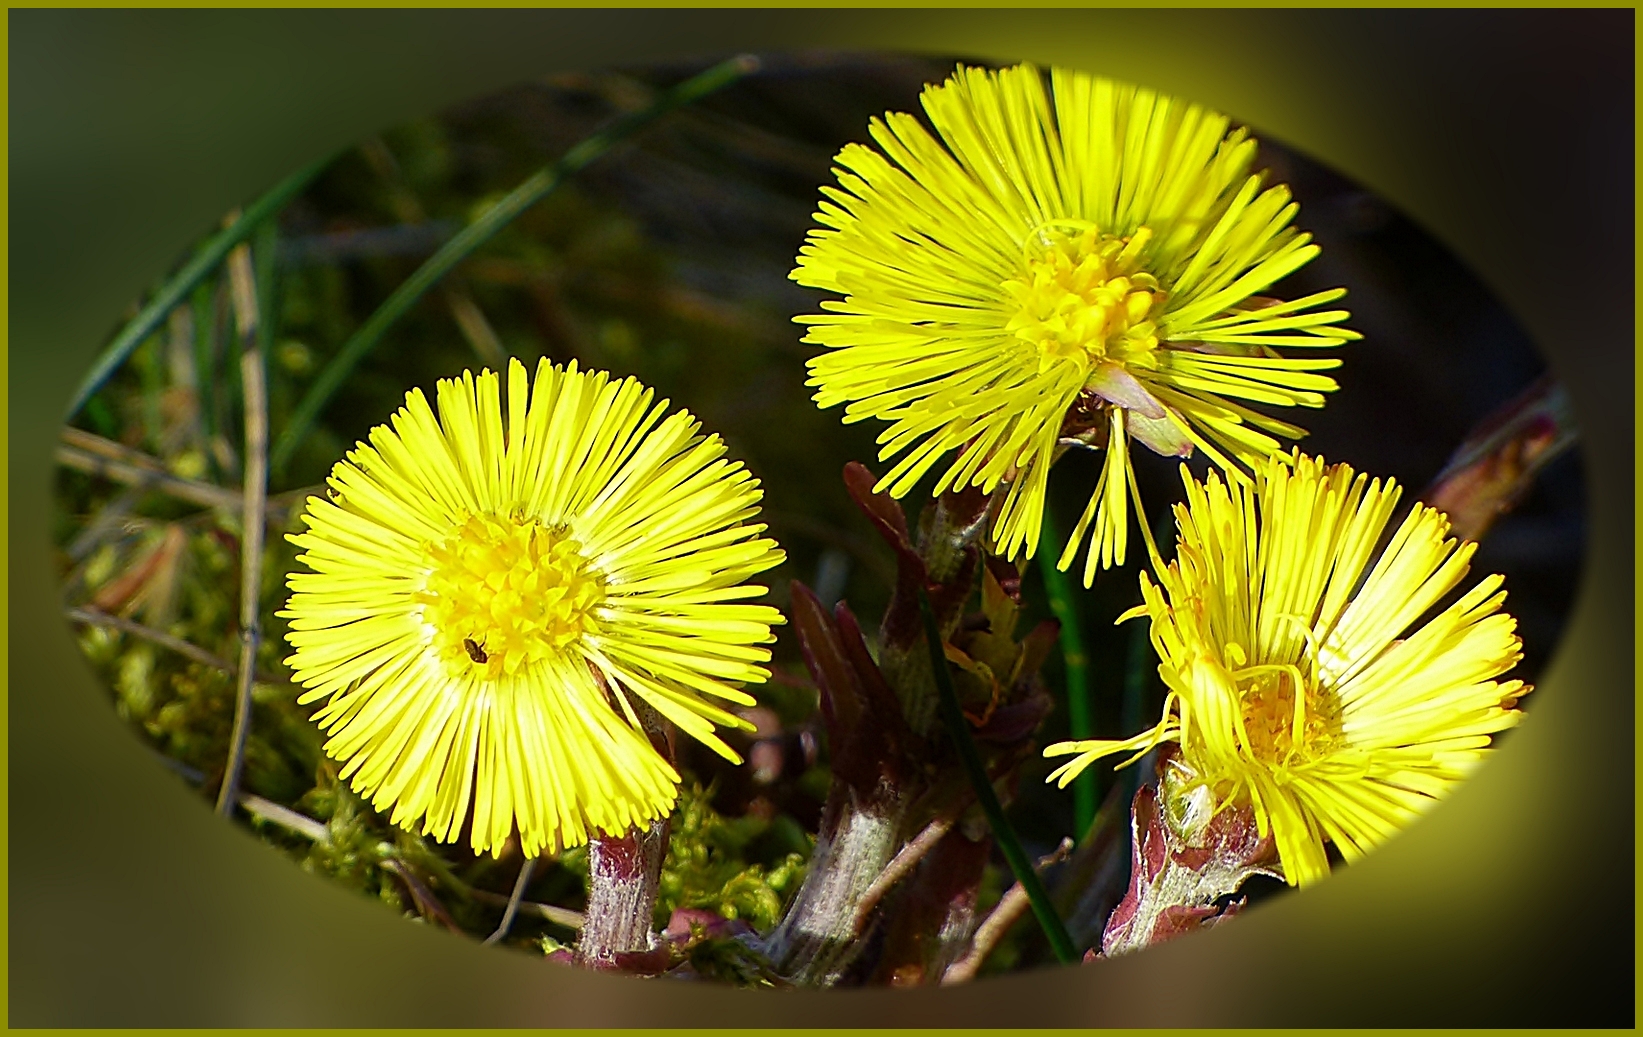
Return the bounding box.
[1045,454,1530,884]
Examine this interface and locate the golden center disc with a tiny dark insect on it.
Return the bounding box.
[417,514,605,679]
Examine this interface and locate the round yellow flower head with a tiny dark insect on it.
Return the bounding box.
[279,360,782,855]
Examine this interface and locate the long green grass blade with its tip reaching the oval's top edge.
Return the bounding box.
[269,54,757,473]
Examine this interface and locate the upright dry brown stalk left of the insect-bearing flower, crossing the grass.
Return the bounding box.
[217,245,273,817]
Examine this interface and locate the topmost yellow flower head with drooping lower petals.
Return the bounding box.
[792,66,1357,585]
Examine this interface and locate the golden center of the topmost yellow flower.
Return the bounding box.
[1002,222,1165,370]
